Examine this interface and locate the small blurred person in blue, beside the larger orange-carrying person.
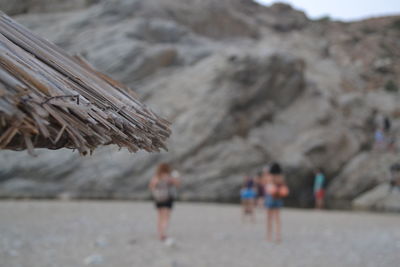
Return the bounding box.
[240,176,257,222]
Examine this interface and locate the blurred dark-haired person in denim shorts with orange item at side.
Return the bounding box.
[265,163,289,245]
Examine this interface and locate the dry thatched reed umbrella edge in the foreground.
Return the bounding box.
[0,12,171,155]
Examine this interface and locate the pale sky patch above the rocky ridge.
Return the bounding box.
[254,0,400,21]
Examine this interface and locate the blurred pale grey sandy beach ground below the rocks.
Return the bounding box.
[0,201,400,267]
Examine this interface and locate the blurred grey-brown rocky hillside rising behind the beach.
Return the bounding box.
[0,0,400,207]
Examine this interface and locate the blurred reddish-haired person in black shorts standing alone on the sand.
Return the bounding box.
[149,163,180,243]
